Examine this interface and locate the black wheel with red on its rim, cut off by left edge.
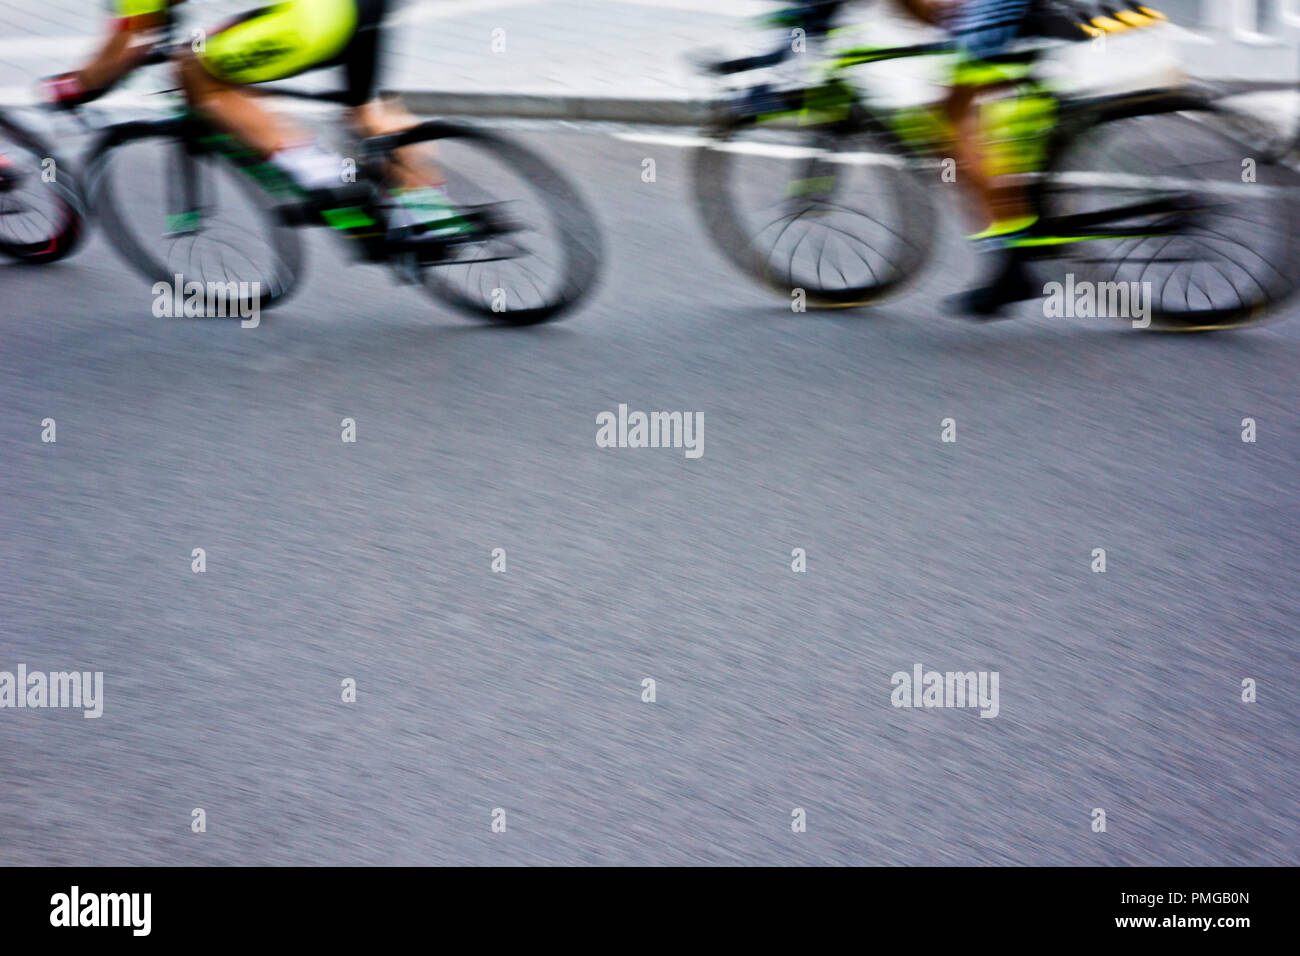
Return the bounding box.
[0,113,86,263]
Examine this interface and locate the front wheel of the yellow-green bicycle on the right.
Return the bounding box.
[694,126,935,308]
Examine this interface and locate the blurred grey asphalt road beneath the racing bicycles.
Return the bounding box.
[0,131,1300,865]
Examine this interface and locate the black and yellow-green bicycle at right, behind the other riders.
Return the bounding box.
[694,3,1300,332]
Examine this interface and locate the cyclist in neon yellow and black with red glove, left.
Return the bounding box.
[42,0,463,234]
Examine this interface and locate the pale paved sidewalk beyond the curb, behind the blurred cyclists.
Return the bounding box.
[0,0,1297,122]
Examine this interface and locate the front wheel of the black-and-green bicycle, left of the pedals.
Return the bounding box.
[91,117,302,313]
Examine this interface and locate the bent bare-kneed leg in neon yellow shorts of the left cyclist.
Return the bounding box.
[178,0,358,156]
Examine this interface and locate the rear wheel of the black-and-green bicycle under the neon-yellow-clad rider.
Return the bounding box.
[377,121,601,325]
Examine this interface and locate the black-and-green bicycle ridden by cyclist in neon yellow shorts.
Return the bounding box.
[79,44,601,325]
